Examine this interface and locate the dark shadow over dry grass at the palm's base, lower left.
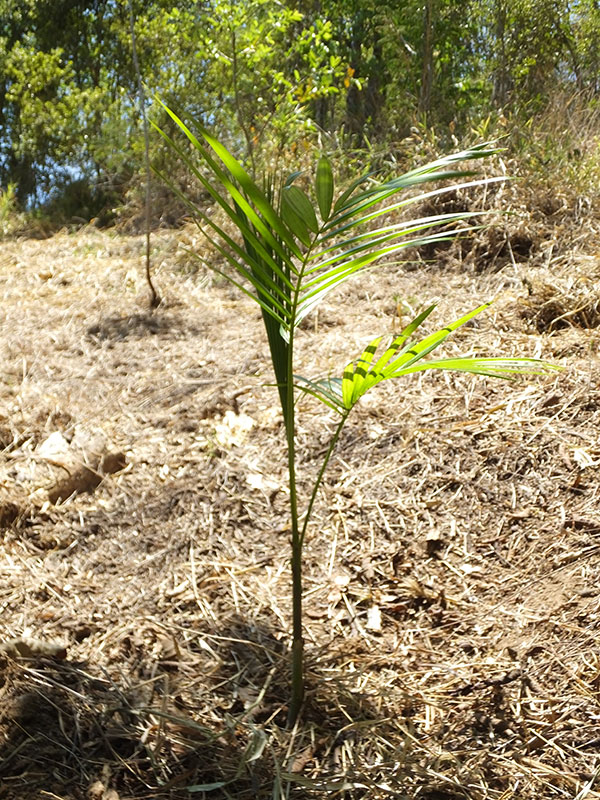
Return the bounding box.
[0,619,398,800]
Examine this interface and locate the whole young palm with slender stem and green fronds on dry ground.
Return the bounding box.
[157,106,554,724]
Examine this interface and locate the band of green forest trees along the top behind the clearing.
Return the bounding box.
[0,0,600,213]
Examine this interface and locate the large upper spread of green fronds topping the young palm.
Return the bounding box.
[157,101,503,338]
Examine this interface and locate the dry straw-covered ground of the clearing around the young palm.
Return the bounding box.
[0,181,600,800]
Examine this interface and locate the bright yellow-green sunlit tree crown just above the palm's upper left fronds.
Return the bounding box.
[195,0,347,169]
